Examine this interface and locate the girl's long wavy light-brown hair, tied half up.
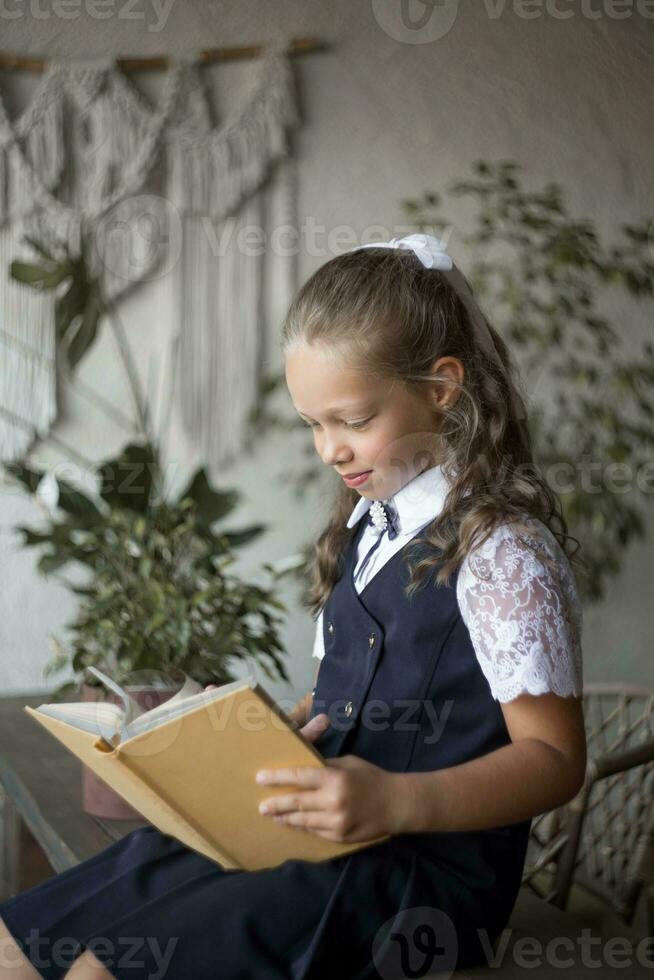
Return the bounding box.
[281,248,580,618]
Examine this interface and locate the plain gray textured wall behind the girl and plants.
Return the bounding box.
[0,0,654,698]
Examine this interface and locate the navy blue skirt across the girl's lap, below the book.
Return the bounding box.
[0,826,510,980]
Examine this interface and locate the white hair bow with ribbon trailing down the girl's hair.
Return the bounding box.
[350,233,525,419]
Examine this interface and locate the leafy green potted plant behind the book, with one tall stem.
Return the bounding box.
[5,240,298,818]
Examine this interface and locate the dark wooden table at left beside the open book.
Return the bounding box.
[0,691,146,899]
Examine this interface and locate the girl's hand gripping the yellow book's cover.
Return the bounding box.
[257,756,408,844]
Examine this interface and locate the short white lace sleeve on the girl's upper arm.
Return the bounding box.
[457,518,583,701]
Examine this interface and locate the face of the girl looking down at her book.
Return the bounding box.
[286,344,446,500]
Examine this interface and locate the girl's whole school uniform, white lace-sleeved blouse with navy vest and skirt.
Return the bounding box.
[0,466,582,980]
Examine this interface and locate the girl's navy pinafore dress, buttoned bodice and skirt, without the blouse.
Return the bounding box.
[0,521,531,980]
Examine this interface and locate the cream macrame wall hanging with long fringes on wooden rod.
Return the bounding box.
[0,34,306,466]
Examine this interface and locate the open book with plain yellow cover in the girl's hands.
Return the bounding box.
[24,667,388,871]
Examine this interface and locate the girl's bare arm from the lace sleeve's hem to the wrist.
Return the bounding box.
[394,692,586,833]
